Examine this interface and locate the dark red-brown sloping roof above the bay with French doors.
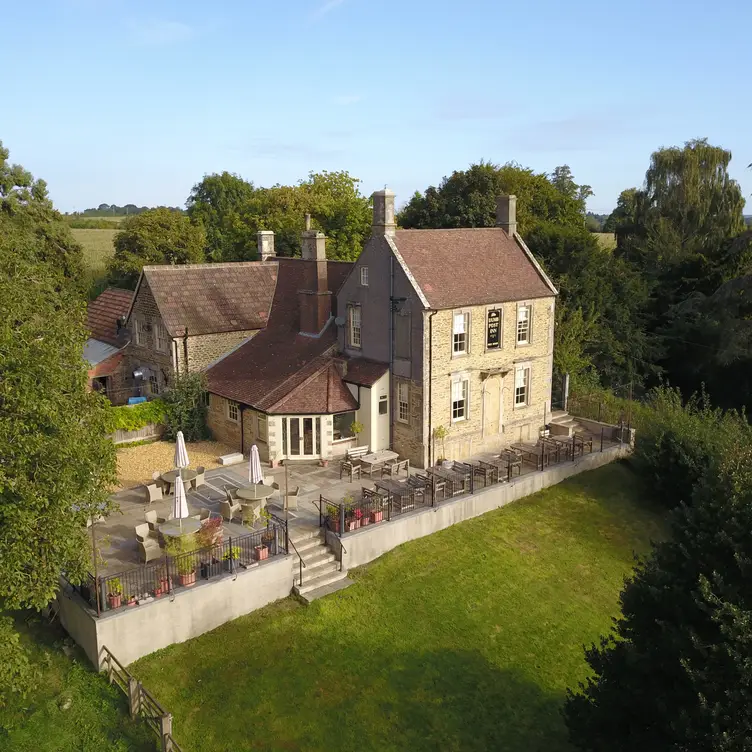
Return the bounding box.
[206,258,354,413]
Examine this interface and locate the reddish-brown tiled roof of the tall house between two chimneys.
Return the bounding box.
[394,227,556,308]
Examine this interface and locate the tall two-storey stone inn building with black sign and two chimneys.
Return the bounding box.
[337,190,557,467]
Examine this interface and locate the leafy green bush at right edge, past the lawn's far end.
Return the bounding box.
[633,387,752,508]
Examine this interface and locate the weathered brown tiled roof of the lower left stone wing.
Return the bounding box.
[144,261,278,337]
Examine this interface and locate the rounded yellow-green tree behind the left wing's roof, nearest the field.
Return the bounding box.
[110,207,206,289]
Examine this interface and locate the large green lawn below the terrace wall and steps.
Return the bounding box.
[132,464,663,752]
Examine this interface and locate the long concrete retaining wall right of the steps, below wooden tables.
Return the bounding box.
[342,444,631,569]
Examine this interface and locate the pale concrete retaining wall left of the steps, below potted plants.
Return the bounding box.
[58,556,293,668]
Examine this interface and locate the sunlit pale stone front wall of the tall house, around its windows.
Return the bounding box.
[424,297,554,460]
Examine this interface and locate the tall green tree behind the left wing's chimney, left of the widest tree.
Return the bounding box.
[186,171,256,261]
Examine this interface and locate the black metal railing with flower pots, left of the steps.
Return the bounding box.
[65,516,291,616]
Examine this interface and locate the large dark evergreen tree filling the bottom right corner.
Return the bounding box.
[565,442,752,752]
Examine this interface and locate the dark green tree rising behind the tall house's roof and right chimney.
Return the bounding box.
[398,162,590,236]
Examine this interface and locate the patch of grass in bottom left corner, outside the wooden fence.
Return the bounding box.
[0,613,157,752]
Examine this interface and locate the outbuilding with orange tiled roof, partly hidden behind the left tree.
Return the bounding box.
[84,287,133,405]
